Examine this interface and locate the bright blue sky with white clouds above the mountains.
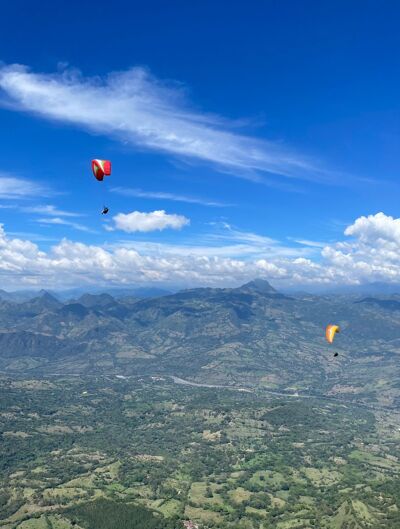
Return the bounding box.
[0,0,400,288]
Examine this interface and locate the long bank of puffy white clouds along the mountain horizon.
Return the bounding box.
[0,213,400,288]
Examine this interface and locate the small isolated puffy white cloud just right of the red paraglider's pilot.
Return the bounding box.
[113,210,190,233]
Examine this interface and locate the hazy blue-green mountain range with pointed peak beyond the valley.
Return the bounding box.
[0,280,400,407]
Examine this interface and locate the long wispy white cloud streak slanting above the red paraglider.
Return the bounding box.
[0,65,328,180]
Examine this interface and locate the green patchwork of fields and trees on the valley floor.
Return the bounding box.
[0,377,400,529]
